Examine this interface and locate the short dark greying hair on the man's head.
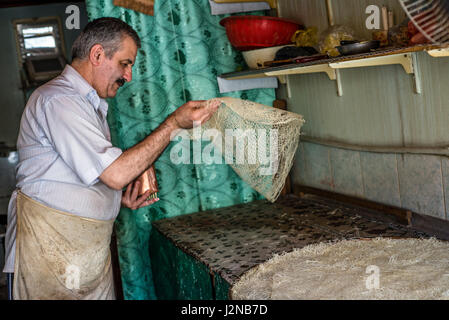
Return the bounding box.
[72,17,140,61]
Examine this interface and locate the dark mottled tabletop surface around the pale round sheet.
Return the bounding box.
[153,195,430,285]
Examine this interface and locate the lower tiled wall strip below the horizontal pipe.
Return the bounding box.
[292,142,449,219]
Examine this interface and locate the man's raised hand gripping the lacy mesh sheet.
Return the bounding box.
[171,99,221,129]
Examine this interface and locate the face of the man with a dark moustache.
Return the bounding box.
[96,36,137,98]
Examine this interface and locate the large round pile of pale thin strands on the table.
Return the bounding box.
[231,238,449,300]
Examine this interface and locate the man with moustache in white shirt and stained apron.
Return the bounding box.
[4,18,218,299]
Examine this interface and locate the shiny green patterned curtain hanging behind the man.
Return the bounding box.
[86,0,275,299]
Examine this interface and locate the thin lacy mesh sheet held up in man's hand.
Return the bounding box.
[189,97,304,202]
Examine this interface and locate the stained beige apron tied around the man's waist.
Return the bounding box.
[13,192,115,300]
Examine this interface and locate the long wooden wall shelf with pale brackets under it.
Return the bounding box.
[220,45,449,96]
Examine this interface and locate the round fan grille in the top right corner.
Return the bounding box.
[399,0,449,44]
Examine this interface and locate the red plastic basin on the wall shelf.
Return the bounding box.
[220,15,302,51]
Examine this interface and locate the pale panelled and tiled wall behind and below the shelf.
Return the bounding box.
[277,0,449,219]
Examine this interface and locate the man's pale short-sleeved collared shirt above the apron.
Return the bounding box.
[3,65,122,272]
